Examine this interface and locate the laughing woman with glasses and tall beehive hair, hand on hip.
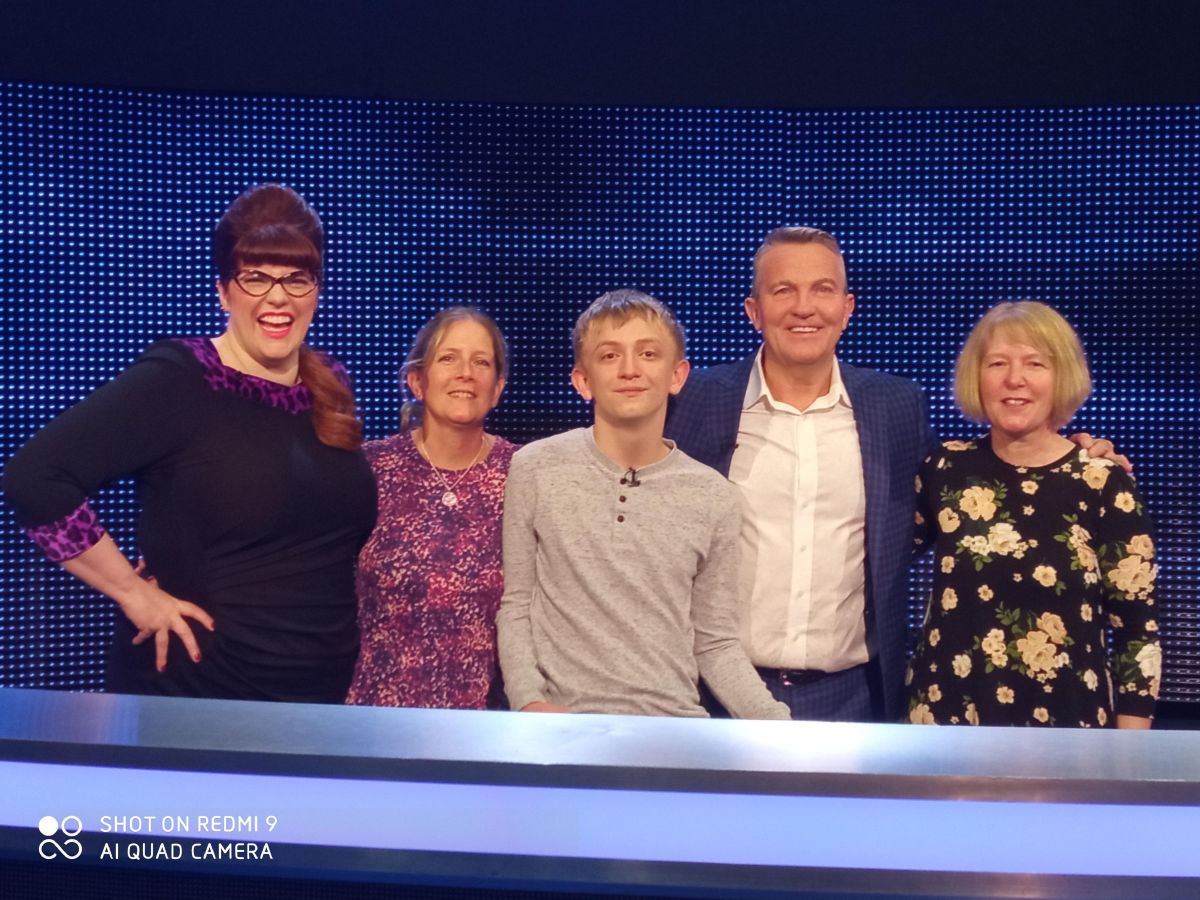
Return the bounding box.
[4,185,376,703]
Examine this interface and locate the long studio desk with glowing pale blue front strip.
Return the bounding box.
[0,689,1200,898]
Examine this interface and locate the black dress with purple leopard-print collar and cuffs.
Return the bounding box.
[5,338,376,703]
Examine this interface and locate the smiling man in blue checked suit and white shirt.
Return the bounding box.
[666,228,936,721]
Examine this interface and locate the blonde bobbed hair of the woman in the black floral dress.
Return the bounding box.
[954,300,1092,430]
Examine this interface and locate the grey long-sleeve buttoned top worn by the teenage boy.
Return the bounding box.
[497,428,788,719]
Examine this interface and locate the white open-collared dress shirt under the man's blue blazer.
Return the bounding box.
[730,349,868,672]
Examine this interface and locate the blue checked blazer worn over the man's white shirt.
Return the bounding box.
[666,356,936,721]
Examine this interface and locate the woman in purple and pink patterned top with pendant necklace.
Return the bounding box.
[347,306,516,709]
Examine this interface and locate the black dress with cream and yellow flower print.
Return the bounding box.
[906,436,1162,727]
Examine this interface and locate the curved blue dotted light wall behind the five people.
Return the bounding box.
[0,84,1200,701]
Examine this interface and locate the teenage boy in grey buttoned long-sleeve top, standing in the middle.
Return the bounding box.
[497,290,788,719]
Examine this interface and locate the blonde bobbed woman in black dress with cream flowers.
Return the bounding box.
[908,302,1162,728]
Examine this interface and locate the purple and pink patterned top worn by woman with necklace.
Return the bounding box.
[346,432,516,709]
